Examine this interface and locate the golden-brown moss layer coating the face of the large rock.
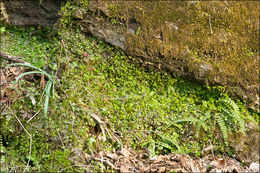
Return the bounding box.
[88,1,259,98]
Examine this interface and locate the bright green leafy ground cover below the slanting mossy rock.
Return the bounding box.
[1,26,258,171]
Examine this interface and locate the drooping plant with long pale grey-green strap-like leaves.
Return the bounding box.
[6,63,55,116]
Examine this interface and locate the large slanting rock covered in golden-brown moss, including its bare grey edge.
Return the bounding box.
[65,1,259,111]
